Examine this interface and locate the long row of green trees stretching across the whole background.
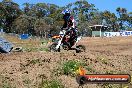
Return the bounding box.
[0,0,132,36]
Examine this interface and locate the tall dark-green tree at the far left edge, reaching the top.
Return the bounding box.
[0,0,21,32]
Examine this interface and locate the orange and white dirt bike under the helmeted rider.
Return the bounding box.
[49,29,85,53]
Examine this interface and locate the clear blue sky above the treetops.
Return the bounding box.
[0,0,132,13]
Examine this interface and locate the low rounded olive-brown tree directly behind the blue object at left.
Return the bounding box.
[12,15,36,34]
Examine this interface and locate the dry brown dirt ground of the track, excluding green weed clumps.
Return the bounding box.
[0,37,132,88]
